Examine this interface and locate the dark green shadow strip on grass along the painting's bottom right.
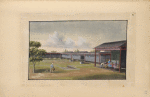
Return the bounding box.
[73,74,126,80]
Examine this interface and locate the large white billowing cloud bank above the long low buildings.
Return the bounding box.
[44,31,90,49]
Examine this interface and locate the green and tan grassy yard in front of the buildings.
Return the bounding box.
[29,59,125,80]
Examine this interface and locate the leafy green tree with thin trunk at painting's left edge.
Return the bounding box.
[29,41,46,73]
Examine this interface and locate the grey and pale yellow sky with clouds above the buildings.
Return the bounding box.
[30,20,127,52]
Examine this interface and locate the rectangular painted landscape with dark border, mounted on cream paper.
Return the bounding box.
[28,20,128,80]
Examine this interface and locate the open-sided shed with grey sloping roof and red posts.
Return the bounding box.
[94,40,127,72]
